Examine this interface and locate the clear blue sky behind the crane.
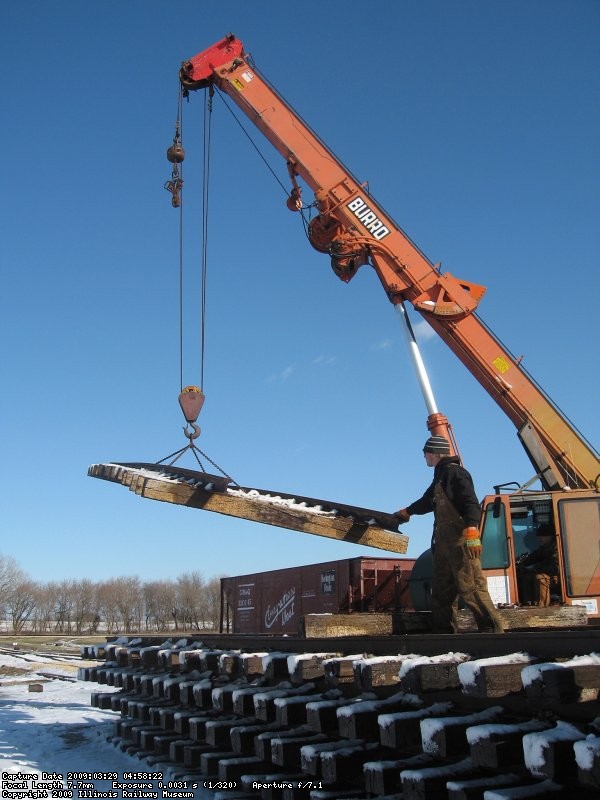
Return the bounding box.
[0,0,600,581]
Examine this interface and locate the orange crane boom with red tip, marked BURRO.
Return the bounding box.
[180,35,600,489]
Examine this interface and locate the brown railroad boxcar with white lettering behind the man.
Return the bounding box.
[221,556,415,635]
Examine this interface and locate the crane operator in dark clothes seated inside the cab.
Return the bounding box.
[517,523,558,606]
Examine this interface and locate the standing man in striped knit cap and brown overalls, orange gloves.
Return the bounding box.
[395,436,504,633]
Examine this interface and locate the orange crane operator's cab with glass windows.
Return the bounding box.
[481,490,600,623]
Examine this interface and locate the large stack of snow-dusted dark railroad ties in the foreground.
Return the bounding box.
[79,638,600,800]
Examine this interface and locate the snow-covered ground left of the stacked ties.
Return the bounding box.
[0,653,212,800]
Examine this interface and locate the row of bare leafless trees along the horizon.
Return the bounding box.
[0,554,221,635]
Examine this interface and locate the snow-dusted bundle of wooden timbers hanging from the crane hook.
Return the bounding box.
[88,462,408,553]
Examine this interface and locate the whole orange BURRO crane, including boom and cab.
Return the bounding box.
[180,34,600,617]
